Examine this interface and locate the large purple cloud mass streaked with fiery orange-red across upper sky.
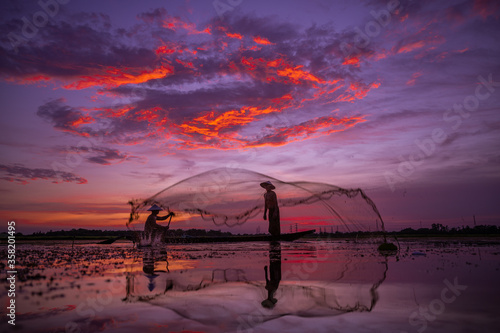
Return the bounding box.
[0,9,386,150]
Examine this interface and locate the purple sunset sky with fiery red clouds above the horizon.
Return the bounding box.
[0,0,500,233]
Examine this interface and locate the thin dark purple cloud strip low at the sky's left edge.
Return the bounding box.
[0,164,87,185]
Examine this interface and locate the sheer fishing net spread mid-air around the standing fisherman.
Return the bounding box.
[127,168,384,232]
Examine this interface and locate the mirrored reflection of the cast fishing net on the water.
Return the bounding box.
[123,242,388,332]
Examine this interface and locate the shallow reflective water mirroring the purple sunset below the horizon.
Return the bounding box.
[0,239,500,332]
